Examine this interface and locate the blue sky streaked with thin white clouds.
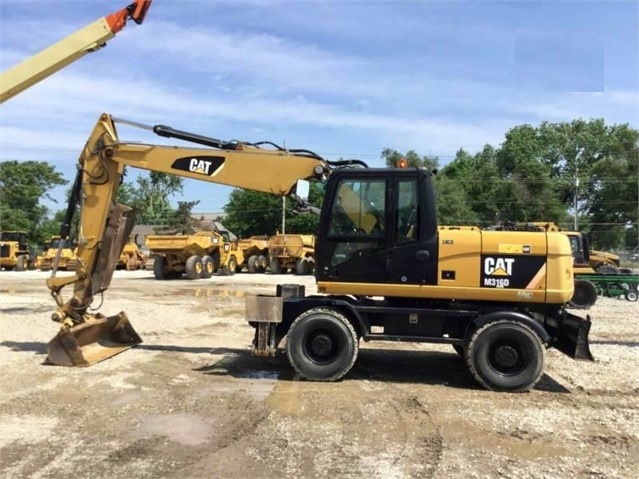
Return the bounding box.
[0,0,639,212]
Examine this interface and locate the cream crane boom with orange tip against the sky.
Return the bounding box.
[0,0,152,103]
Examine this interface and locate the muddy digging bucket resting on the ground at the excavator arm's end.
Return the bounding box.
[47,312,142,366]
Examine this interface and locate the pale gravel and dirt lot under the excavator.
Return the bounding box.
[0,271,639,479]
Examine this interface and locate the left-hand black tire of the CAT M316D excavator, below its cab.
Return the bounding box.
[286,307,359,381]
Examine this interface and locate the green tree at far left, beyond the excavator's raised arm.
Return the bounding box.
[0,161,68,243]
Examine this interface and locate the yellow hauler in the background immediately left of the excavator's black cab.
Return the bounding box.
[268,233,315,275]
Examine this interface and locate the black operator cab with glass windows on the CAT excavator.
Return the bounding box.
[316,169,437,285]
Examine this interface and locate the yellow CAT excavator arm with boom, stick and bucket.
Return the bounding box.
[47,113,331,366]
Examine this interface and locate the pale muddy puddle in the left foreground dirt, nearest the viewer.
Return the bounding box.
[134,413,212,446]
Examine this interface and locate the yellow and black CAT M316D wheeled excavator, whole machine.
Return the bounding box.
[47,113,592,391]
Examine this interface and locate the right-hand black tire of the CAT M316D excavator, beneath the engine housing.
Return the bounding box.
[465,319,546,392]
